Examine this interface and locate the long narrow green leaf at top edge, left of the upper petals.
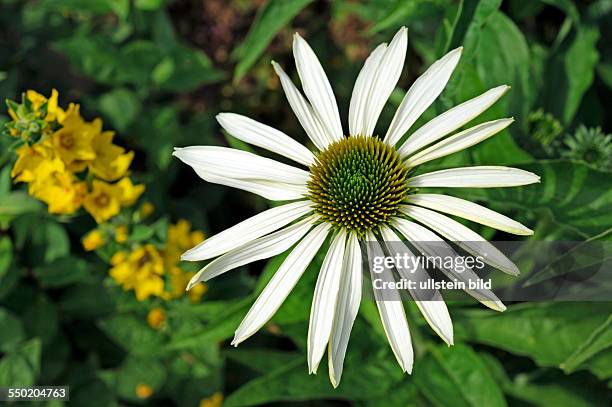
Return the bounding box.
[232,0,312,82]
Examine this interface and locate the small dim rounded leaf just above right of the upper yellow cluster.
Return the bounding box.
[99,88,141,132]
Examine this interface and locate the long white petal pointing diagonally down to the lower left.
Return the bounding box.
[232,223,330,346]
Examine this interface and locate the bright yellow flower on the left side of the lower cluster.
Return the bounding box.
[110,244,164,301]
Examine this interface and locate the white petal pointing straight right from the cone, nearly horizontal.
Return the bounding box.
[408,166,540,188]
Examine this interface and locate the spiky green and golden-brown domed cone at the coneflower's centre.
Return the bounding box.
[308,136,408,236]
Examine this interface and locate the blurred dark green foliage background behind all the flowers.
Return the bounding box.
[0,0,612,406]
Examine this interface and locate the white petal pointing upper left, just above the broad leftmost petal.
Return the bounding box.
[217,113,314,166]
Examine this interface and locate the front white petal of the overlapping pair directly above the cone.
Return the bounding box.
[363,27,408,136]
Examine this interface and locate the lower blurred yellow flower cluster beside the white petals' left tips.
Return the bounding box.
[109,219,206,303]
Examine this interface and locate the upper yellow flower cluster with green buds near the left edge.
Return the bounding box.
[9,90,144,223]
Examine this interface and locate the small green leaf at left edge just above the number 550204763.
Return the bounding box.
[0,338,40,387]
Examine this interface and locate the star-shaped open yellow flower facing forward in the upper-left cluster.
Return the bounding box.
[51,104,100,169]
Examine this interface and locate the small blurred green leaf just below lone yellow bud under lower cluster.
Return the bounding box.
[98,315,163,356]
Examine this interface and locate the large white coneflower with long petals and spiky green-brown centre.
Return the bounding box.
[174,28,539,386]
